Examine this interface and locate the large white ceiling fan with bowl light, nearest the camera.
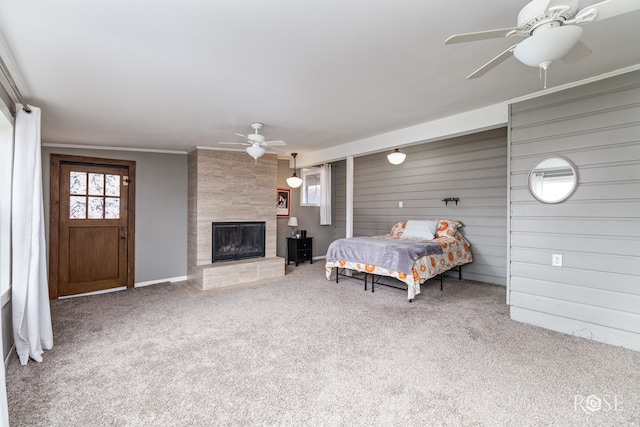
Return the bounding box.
[444,0,640,88]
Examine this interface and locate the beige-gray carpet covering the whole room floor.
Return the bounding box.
[7,262,640,426]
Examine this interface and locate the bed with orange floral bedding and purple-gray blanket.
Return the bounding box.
[325,219,473,302]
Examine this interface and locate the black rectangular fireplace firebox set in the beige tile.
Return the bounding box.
[211,221,266,263]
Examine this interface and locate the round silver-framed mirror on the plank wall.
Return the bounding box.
[529,156,578,203]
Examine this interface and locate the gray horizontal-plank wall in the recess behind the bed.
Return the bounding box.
[335,128,507,285]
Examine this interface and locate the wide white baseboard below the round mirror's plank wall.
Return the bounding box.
[511,306,640,351]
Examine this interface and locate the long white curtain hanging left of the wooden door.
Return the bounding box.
[11,105,53,365]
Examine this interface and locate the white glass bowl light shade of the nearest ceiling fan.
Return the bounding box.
[513,25,582,69]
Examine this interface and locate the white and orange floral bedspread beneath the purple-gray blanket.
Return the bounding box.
[325,233,473,299]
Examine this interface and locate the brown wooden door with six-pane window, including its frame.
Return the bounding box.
[49,155,135,298]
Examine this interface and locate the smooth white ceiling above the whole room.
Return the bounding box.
[0,0,640,163]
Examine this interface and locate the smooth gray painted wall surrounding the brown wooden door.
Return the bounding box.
[42,147,187,283]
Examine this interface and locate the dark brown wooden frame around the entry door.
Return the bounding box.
[49,154,136,299]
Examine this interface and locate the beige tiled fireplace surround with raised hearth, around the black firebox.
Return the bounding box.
[187,149,284,290]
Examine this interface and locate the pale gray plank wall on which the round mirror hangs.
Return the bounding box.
[510,72,640,350]
